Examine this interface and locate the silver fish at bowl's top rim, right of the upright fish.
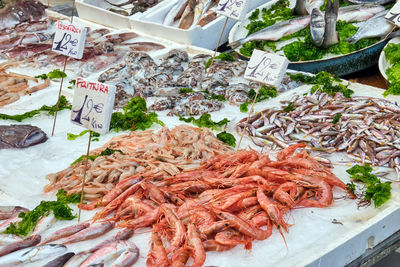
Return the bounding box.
[338,5,385,22]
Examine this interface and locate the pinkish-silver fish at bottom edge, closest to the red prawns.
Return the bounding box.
[80,241,135,267]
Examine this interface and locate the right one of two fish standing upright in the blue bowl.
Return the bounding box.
[321,0,339,48]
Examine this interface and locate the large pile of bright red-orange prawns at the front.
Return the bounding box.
[81,144,353,266]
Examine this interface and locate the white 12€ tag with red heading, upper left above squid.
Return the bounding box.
[52,20,86,59]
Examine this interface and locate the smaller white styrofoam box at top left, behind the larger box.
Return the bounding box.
[75,0,170,29]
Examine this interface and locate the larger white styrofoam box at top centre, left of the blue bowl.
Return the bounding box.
[130,0,269,49]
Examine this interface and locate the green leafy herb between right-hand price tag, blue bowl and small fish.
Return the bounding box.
[289,71,354,98]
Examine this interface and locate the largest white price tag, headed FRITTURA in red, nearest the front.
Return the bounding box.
[71,78,116,134]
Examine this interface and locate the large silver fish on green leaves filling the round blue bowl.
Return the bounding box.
[229,0,394,62]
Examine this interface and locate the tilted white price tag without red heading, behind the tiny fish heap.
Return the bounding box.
[244,50,289,87]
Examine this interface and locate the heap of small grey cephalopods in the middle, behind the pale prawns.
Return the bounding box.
[98,49,297,113]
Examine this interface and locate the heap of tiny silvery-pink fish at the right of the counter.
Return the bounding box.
[237,91,400,175]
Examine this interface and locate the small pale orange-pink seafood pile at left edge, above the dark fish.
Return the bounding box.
[0,69,50,107]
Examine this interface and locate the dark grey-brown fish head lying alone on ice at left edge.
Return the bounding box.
[0,125,47,149]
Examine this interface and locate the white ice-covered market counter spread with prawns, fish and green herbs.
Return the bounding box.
[0,0,400,266]
